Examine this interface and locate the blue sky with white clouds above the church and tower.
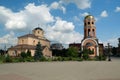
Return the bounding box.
[0,0,120,48]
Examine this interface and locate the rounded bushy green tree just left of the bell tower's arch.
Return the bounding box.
[67,47,78,57]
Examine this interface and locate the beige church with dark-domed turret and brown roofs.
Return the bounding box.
[8,27,52,57]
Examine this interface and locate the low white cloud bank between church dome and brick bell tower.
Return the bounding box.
[46,27,83,44]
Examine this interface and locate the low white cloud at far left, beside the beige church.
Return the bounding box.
[0,32,17,48]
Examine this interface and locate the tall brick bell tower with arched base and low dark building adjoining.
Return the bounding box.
[69,15,103,57]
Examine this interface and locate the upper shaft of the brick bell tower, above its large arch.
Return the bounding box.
[84,15,96,39]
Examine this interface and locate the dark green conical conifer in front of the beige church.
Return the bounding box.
[34,42,42,61]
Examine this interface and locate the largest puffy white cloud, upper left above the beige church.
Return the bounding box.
[0,3,54,30]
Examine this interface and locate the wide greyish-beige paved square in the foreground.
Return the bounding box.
[0,58,120,80]
